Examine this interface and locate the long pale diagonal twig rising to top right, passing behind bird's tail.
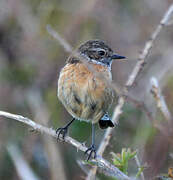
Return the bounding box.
[86,4,173,180]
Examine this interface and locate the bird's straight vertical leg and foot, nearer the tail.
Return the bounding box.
[85,124,96,161]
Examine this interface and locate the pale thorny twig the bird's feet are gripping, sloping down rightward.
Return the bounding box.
[0,111,131,180]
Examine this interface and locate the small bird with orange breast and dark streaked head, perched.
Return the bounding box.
[56,39,126,161]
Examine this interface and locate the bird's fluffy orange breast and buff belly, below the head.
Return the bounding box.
[58,63,114,123]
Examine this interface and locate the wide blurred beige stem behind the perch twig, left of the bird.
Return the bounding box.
[25,88,67,180]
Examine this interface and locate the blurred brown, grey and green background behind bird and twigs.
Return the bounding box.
[0,0,173,180]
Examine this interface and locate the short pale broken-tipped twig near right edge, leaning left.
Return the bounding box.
[150,77,171,122]
